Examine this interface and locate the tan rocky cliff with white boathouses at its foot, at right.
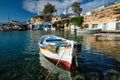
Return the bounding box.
[83,2,120,30]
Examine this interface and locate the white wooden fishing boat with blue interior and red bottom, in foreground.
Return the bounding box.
[38,35,77,70]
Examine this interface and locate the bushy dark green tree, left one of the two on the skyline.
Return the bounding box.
[43,3,55,15]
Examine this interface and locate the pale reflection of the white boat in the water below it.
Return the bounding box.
[39,53,71,80]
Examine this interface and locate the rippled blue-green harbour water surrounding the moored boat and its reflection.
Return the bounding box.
[0,30,120,80]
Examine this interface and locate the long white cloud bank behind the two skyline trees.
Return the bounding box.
[23,0,117,13]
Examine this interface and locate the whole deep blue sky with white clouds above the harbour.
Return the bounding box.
[0,0,120,22]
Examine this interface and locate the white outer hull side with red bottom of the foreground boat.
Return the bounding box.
[40,42,73,70]
